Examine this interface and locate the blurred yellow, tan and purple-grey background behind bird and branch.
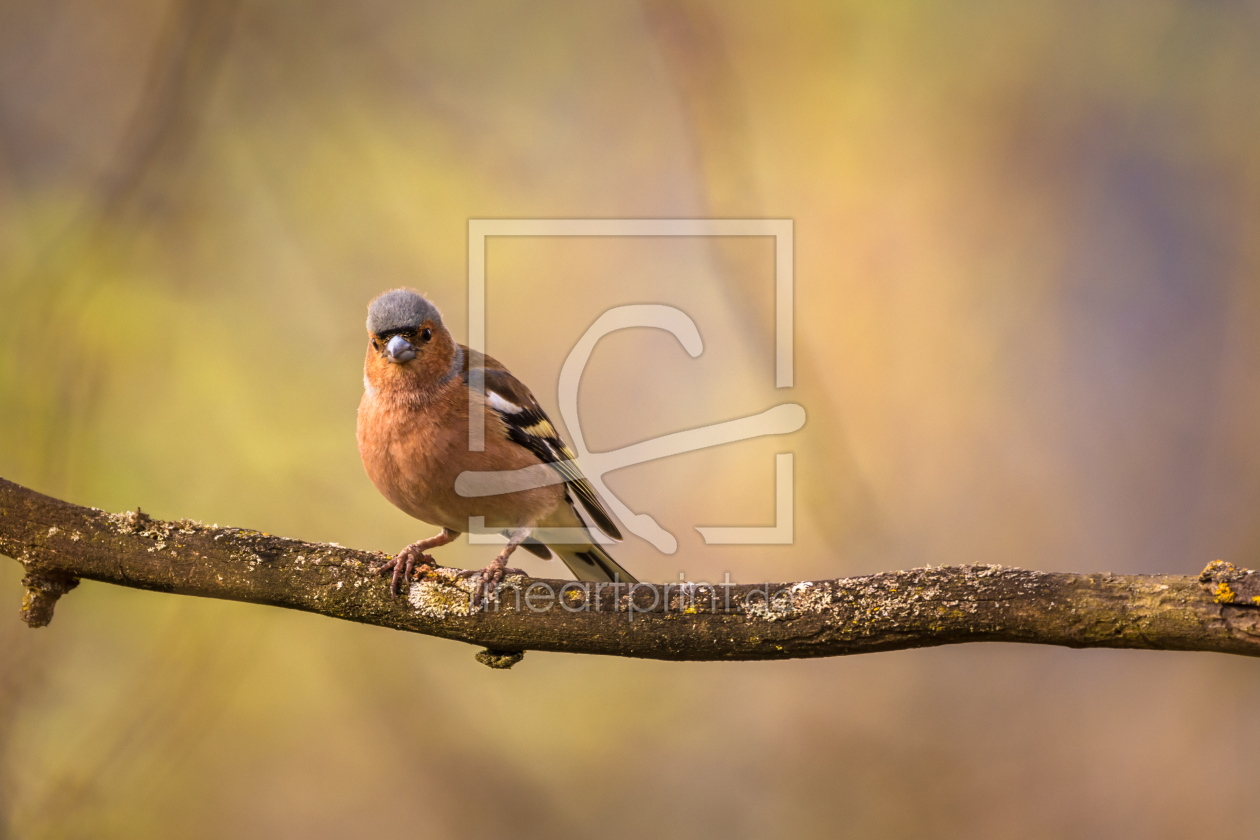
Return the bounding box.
[0,0,1260,839]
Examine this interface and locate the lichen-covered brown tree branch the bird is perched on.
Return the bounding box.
[0,479,1260,667]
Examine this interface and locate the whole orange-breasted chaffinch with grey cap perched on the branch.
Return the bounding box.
[358,288,636,603]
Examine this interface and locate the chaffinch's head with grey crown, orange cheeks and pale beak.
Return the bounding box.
[363,288,455,390]
